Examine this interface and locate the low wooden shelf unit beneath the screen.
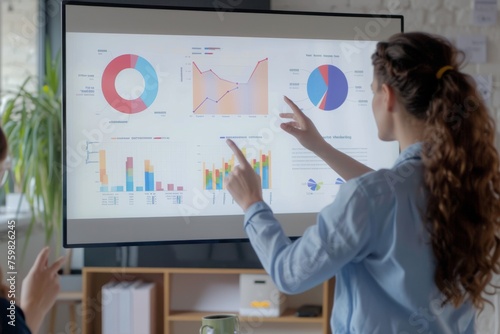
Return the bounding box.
[82,267,335,334]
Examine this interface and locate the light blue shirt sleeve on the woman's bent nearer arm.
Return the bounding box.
[244,180,371,294]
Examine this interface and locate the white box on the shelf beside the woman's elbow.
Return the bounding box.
[240,274,286,317]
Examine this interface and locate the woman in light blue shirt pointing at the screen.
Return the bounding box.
[226,33,500,334]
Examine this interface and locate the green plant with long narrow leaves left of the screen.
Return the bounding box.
[2,47,62,248]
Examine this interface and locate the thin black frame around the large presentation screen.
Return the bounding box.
[62,0,404,248]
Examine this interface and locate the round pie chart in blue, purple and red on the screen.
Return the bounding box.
[307,65,348,111]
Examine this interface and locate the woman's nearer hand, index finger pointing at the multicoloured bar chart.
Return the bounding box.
[224,139,262,212]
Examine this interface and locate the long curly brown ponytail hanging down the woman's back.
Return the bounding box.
[422,70,500,308]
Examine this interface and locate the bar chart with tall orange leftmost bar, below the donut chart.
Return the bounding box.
[99,150,184,192]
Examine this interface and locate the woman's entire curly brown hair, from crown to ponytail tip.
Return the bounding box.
[372,33,500,309]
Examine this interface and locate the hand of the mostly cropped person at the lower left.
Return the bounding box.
[20,247,66,334]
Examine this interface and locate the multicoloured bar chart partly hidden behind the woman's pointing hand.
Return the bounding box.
[202,148,272,190]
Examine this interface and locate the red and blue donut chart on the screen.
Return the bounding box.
[101,54,158,114]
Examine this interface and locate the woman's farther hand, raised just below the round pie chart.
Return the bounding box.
[280,96,327,152]
